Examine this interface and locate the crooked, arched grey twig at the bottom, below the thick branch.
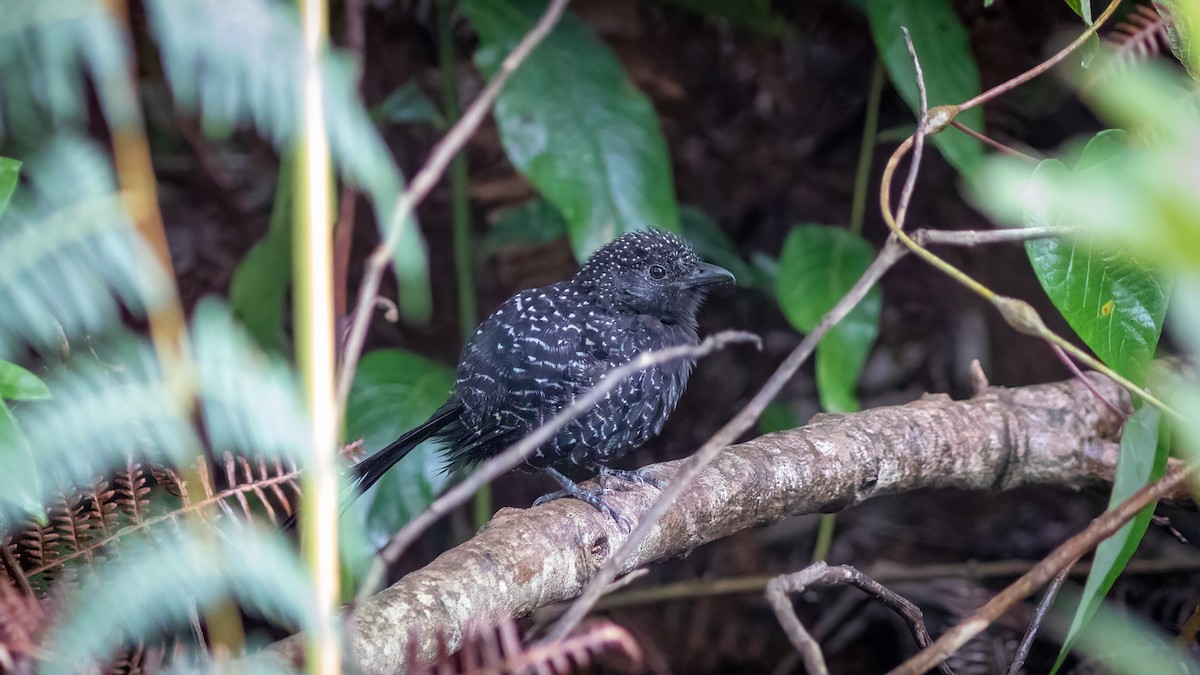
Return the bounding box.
[767,561,954,675]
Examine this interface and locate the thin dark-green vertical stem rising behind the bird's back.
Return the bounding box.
[438,0,492,530]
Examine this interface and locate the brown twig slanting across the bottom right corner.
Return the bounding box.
[890,466,1194,675]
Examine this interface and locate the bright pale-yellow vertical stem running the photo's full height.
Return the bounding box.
[293,0,341,675]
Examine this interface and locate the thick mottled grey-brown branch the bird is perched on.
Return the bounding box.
[276,374,1129,673]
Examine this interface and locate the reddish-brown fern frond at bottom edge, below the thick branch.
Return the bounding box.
[409,619,643,675]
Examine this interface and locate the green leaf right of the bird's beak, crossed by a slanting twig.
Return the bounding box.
[776,225,883,412]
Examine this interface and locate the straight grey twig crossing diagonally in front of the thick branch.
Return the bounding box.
[547,238,905,640]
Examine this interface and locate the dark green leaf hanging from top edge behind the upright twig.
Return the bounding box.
[866,0,983,178]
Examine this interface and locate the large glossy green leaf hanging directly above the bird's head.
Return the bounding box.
[462,0,679,261]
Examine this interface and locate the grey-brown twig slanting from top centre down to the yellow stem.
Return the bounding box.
[337,0,570,410]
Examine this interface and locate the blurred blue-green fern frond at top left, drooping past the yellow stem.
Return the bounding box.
[146,0,430,315]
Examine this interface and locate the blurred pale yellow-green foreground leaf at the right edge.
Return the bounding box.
[972,64,1200,270]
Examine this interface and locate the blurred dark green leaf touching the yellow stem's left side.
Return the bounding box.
[229,153,295,351]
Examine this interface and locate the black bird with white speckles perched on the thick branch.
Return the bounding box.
[354,231,733,530]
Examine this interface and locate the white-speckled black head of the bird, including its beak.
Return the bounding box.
[575,229,733,323]
